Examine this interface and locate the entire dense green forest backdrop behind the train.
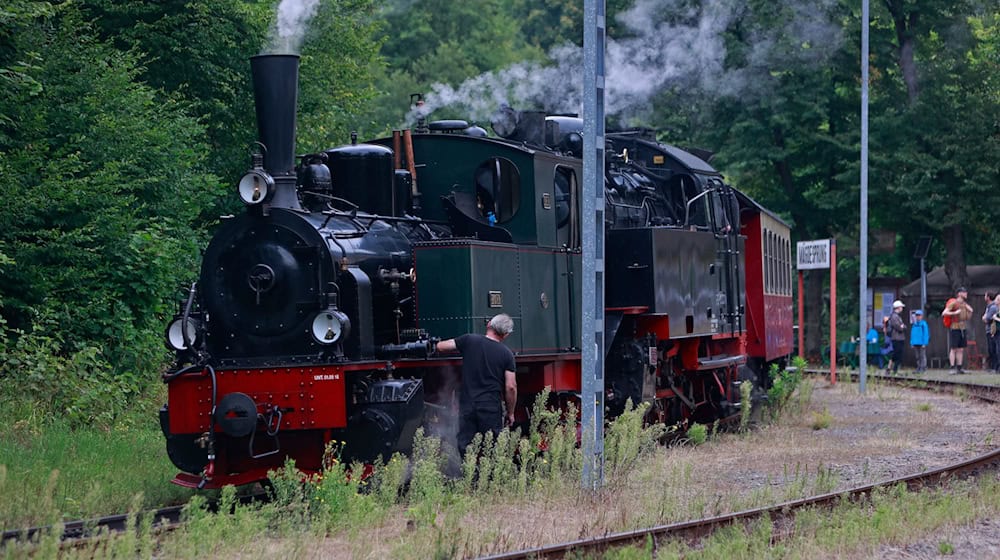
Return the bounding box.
[0,0,1000,422]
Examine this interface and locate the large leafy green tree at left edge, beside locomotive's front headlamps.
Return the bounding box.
[0,4,218,373]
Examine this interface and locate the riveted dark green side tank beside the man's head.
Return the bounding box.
[413,240,524,353]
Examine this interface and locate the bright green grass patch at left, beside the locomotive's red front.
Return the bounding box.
[0,380,191,530]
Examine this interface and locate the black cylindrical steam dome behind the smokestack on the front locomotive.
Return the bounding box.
[326,144,395,216]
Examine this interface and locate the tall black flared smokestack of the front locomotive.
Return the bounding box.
[250,54,299,208]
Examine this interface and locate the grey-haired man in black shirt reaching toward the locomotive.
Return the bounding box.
[437,313,517,457]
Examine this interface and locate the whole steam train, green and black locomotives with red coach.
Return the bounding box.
[160,55,792,488]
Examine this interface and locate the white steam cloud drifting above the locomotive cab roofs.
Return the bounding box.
[408,0,841,122]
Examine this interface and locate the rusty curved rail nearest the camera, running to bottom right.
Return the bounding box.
[480,450,1000,560]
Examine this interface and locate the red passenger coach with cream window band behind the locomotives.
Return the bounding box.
[741,197,793,370]
